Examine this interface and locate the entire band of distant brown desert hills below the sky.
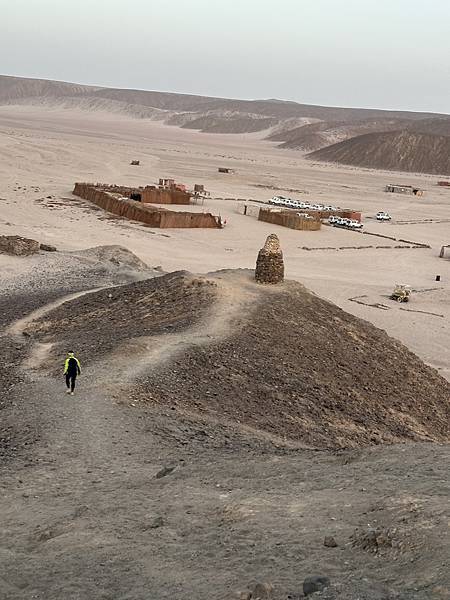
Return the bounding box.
[0,75,450,175]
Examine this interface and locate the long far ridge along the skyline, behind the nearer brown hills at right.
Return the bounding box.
[0,76,444,133]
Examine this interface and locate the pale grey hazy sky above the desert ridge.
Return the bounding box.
[0,0,450,113]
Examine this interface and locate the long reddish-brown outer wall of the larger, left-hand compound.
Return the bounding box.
[73,183,220,229]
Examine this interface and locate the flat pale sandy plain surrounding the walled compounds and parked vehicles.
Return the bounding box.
[0,106,450,379]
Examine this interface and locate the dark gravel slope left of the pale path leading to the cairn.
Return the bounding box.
[27,271,219,365]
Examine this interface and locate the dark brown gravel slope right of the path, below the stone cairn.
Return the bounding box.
[137,274,450,448]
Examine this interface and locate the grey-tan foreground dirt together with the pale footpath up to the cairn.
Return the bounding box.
[0,273,448,600]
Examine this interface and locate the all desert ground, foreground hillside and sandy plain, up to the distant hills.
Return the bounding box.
[0,105,450,600]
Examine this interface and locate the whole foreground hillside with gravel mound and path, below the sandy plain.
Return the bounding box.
[0,246,449,600]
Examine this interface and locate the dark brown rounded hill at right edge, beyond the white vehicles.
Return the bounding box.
[308,130,450,175]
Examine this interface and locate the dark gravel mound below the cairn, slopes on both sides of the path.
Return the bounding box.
[25,272,450,448]
